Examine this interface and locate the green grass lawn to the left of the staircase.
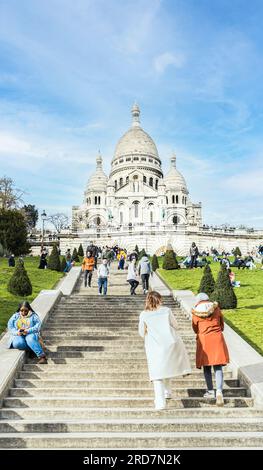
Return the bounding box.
[0,257,63,333]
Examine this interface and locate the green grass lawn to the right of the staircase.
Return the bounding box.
[158,259,263,354]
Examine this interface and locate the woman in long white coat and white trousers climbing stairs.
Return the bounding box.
[139,291,191,410]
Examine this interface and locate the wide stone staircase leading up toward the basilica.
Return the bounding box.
[0,265,263,449]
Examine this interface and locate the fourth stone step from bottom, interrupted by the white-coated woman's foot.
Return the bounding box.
[3,396,253,408]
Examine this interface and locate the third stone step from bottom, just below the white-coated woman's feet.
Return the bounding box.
[0,402,262,422]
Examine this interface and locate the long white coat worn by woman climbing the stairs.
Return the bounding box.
[139,307,191,380]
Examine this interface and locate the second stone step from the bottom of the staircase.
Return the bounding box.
[0,418,263,433]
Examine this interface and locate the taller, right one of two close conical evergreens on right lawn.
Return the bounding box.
[210,263,237,309]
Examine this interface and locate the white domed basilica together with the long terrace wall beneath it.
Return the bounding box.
[59,104,263,255]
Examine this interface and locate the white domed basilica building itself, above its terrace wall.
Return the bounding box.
[72,104,202,232]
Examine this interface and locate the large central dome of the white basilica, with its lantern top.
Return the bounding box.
[112,104,160,163]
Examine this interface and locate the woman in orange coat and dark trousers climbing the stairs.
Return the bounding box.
[192,293,229,406]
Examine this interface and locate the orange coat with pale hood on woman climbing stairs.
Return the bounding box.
[192,301,229,369]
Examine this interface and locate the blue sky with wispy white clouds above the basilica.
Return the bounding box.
[0,0,263,228]
